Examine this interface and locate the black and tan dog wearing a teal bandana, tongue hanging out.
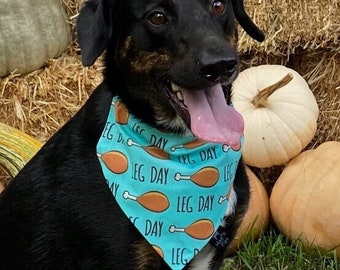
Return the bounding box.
[0,0,263,270]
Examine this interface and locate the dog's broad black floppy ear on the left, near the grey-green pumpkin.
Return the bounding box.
[77,0,119,66]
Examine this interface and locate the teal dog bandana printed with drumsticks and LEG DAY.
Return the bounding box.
[97,97,241,270]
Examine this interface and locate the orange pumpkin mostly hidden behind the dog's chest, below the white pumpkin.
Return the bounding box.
[228,167,269,255]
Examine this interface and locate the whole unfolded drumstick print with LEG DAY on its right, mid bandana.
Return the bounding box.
[123,191,170,212]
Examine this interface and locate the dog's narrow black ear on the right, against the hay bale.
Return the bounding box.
[232,0,265,42]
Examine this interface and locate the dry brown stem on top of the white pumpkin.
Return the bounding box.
[251,73,294,109]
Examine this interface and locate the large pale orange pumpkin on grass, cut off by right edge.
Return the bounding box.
[270,141,340,257]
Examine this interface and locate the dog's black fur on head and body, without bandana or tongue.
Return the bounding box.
[0,0,262,270]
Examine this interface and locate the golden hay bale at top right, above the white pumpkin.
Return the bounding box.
[239,0,340,57]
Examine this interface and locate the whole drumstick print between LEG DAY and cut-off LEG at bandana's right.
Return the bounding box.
[175,167,219,187]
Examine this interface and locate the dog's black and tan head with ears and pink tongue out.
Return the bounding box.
[78,0,264,148]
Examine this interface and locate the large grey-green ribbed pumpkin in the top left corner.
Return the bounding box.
[0,0,71,77]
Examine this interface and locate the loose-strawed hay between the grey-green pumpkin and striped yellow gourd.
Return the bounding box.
[0,48,101,142]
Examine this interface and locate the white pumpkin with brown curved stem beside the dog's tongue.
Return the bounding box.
[232,65,319,168]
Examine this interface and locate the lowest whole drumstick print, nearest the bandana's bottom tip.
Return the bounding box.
[169,219,214,240]
